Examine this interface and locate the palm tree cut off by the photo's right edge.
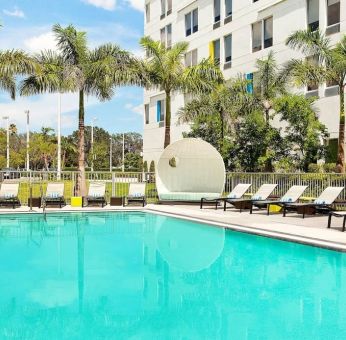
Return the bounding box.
[286,30,346,173]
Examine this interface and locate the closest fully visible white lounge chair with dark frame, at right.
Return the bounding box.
[283,187,344,218]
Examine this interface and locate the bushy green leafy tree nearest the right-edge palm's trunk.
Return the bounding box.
[274,95,328,171]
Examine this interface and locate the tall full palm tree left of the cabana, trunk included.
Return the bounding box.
[21,25,140,196]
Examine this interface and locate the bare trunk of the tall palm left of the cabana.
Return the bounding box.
[76,90,86,196]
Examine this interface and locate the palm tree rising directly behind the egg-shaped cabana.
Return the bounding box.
[140,37,223,148]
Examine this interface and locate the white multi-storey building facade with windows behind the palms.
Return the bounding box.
[143,0,346,164]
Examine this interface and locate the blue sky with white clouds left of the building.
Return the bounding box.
[0,0,144,134]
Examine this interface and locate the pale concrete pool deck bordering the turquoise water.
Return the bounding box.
[0,204,346,252]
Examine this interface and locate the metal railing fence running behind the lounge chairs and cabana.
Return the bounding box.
[0,171,346,205]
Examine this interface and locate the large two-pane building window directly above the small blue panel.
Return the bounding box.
[252,17,273,52]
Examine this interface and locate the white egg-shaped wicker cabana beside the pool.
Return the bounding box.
[156,138,226,201]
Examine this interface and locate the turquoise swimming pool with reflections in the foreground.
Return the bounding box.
[0,212,346,340]
